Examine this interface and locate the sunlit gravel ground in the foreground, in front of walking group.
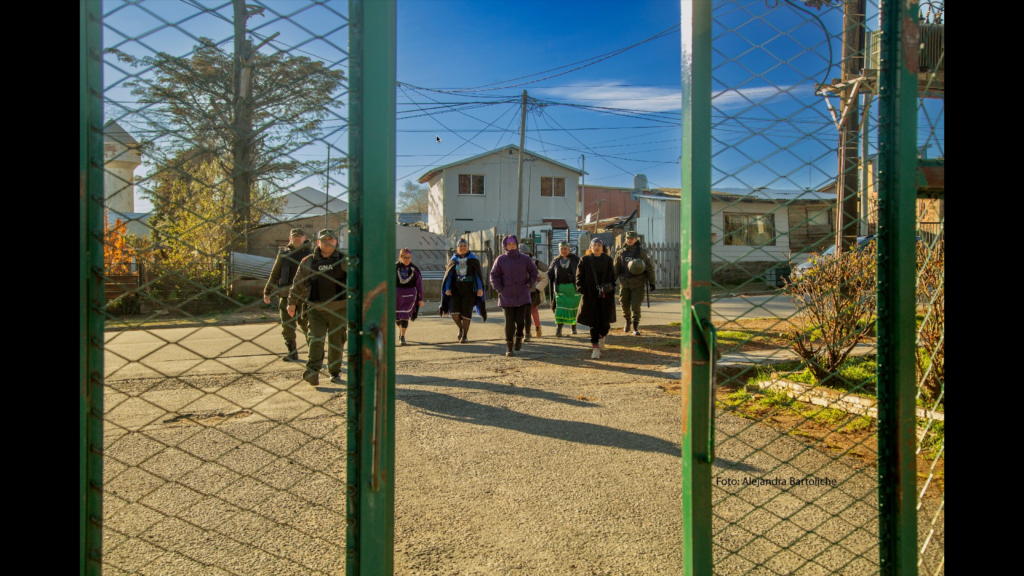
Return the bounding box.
[97,323,943,576]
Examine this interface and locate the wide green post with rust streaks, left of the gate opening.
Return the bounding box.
[346,0,396,576]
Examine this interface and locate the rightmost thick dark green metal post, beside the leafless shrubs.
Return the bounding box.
[878,0,920,576]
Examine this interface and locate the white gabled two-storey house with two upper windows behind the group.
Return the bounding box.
[411,145,583,236]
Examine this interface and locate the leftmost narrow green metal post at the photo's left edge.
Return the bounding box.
[78,0,103,575]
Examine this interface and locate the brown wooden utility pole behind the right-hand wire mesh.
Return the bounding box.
[836,0,866,253]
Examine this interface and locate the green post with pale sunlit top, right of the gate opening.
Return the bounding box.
[680,0,714,575]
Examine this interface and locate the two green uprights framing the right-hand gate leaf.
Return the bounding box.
[680,0,920,576]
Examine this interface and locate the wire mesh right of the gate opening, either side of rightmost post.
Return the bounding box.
[711,0,944,574]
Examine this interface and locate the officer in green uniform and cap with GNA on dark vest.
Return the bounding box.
[288,229,348,386]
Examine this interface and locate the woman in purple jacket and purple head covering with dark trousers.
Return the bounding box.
[490,235,537,356]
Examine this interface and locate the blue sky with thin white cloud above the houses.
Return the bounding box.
[103,0,942,211]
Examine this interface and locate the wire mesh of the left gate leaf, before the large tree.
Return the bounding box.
[96,0,348,575]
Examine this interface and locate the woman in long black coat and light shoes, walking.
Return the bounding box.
[575,238,615,359]
